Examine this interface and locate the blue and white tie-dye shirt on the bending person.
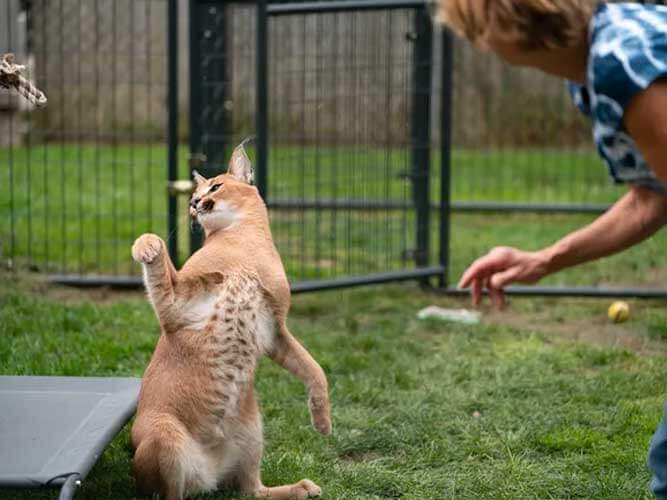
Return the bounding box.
[569,3,667,194]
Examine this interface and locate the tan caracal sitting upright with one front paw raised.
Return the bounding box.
[132,146,331,500]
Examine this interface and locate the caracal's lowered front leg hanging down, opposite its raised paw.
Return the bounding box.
[269,321,331,434]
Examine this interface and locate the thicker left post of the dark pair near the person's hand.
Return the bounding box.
[410,4,433,278]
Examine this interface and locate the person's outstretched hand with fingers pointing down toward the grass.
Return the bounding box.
[459,247,548,307]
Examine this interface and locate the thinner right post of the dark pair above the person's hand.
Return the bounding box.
[440,28,454,288]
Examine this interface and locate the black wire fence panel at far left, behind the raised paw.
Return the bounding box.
[0,0,169,276]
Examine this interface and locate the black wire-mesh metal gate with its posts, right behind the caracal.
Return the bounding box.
[185,0,449,292]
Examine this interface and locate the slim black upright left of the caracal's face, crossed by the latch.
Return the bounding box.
[167,0,178,264]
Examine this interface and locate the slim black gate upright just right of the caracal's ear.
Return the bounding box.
[255,0,269,201]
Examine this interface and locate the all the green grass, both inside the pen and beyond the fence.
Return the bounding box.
[0,145,667,500]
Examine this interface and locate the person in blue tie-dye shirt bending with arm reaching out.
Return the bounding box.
[436,0,667,498]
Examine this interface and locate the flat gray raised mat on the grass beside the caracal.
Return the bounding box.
[0,377,141,488]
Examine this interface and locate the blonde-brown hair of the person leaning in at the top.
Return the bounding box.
[436,0,598,50]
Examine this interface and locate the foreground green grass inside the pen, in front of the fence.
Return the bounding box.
[0,275,667,500]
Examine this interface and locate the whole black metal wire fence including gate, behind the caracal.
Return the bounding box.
[0,0,663,295]
